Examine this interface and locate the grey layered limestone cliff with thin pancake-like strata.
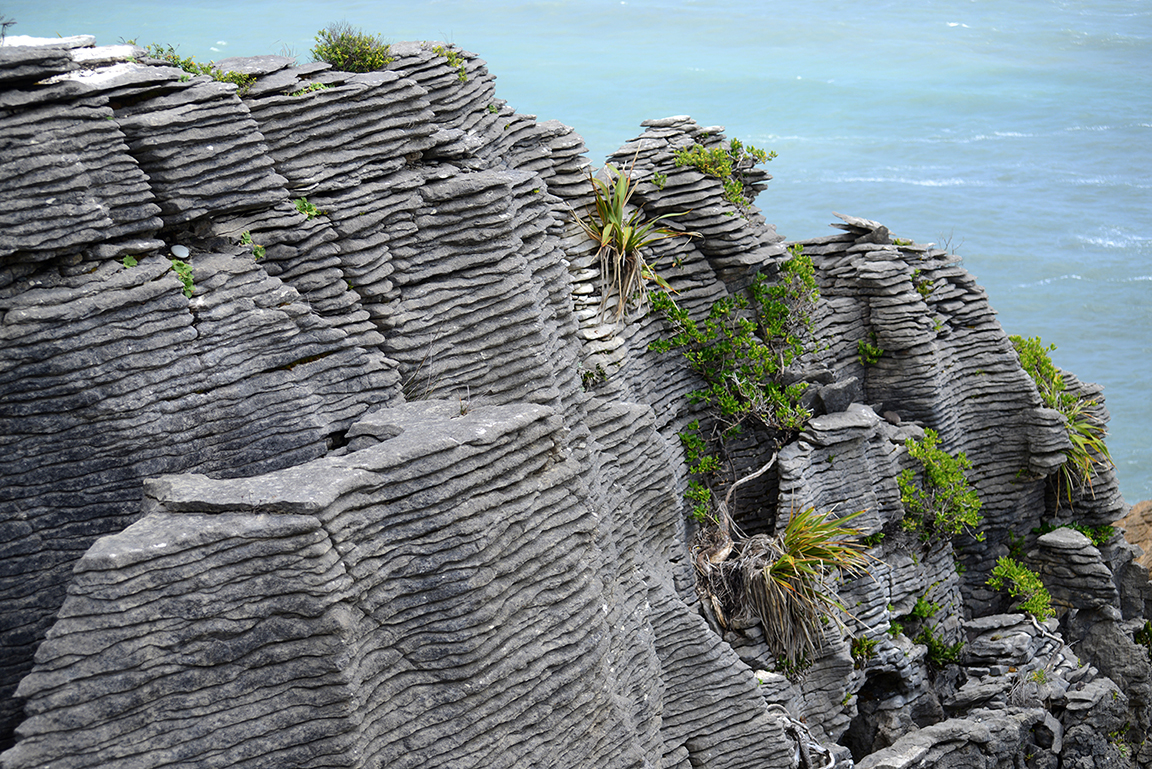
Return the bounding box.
[0,38,1152,769]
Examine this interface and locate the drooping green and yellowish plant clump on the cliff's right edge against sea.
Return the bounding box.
[1008,336,1112,504]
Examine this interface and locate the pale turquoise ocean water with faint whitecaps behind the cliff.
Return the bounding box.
[9,0,1152,502]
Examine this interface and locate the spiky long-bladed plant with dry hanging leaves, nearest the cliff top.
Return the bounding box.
[576,163,699,321]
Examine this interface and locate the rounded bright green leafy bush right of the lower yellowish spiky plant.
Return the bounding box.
[896,429,984,541]
